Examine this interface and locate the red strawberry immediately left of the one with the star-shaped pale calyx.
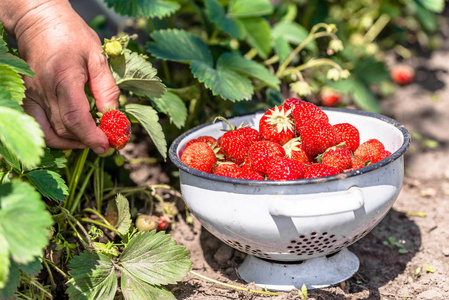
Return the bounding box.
[220,127,262,165]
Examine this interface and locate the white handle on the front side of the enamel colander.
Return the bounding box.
[268,186,365,217]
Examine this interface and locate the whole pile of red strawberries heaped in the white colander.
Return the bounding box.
[181,98,390,180]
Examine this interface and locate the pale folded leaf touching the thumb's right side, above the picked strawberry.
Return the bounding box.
[110,51,165,97]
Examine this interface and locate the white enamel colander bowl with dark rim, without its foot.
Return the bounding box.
[169,108,410,286]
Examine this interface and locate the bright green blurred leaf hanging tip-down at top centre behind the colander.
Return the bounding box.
[241,17,271,59]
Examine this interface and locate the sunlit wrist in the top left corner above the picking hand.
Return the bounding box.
[0,0,71,38]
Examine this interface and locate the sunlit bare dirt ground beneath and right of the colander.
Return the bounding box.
[157,50,449,300]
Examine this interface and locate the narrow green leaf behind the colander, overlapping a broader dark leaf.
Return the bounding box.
[217,52,280,89]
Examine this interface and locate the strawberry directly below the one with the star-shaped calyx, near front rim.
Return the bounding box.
[248,141,285,175]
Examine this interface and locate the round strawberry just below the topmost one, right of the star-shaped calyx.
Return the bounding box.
[301,119,337,156]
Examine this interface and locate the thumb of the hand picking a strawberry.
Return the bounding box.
[87,52,120,112]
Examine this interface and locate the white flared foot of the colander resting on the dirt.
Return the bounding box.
[238,248,360,291]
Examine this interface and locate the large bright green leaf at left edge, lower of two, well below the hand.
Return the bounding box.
[0,180,53,264]
